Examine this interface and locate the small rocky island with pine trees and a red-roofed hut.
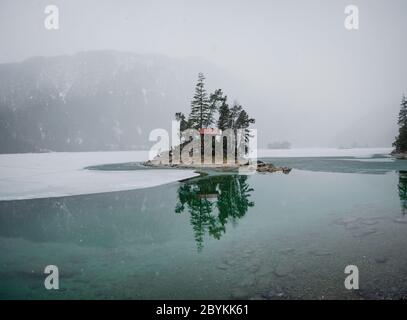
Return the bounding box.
[144,73,291,174]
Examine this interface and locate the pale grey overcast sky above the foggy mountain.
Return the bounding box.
[0,0,407,146]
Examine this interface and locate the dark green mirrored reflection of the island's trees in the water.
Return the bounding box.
[175,175,254,251]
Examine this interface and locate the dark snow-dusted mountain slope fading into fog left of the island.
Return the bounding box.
[0,51,228,153]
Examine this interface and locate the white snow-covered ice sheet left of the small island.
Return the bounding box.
[0,151,197,201]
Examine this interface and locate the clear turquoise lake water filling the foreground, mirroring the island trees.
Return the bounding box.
[0,157,407,299]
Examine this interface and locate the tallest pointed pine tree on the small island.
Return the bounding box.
[188,73,211,129]
